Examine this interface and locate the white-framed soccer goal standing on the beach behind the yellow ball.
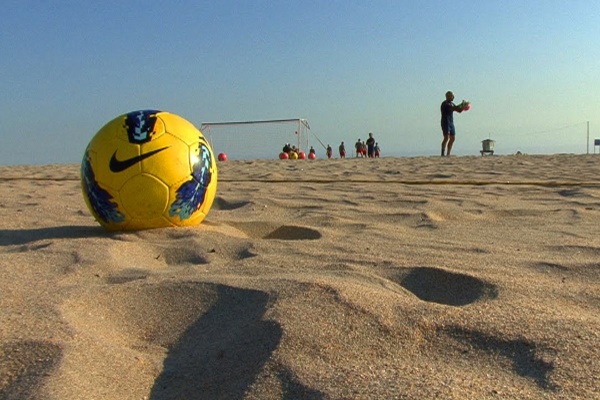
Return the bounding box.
[200,118,310,160]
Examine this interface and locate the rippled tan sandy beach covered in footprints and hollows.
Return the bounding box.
[0,155,600,400]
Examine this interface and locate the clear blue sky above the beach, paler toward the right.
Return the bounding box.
[0,0,600,165]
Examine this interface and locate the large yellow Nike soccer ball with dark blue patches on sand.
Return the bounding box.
[81,110,217,231]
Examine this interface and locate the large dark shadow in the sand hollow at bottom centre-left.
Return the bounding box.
[150,285,282,400]
